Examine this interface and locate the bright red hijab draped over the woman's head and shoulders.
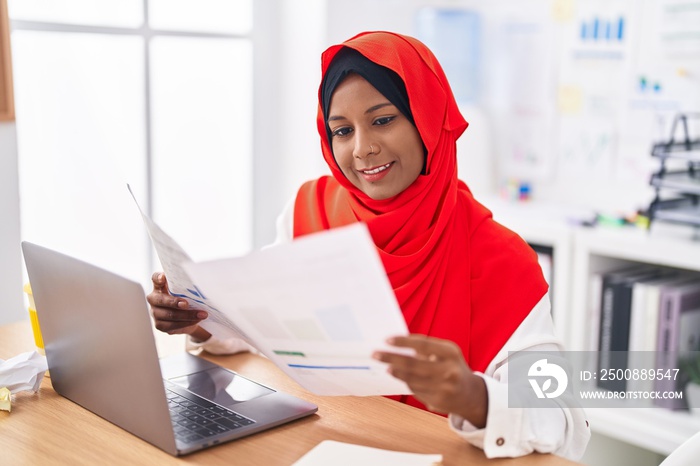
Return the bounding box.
[294,32,547,408]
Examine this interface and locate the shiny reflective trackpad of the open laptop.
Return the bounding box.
[169,367,274,406]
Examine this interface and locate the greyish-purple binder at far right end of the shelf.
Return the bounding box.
[654,279,700,410]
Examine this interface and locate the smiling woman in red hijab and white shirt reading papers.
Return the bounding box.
[149,32,590,458]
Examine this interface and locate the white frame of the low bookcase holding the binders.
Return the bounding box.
[484,200,700,455]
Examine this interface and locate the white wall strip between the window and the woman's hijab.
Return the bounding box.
[254,0,328,248]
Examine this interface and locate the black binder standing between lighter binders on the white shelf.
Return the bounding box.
[597,266,662,391]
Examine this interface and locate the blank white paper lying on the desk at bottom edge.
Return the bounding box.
[292,440,442,466]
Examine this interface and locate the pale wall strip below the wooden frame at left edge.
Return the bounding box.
[0,123,28,325]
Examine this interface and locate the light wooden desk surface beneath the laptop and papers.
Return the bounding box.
[0,322,575,466]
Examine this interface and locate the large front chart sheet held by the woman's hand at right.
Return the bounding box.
[184,223,411,396]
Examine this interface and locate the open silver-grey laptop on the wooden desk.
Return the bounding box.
[22,241,318,456]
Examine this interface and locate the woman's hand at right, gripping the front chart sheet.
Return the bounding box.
[374,335,488,428]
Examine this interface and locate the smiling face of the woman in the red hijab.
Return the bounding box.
[328,74,425,200]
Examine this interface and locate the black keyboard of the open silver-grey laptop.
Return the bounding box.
[165,383,255,443]
